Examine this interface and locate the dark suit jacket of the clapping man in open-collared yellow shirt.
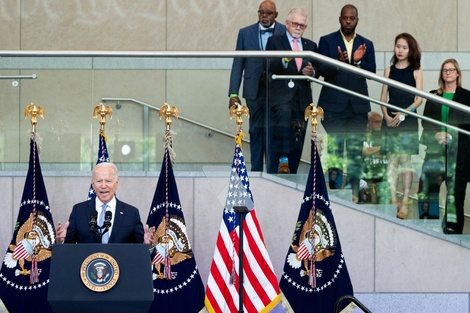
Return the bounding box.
[318,30,376,113]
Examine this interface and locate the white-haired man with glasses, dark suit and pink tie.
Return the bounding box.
[266,9,318,174]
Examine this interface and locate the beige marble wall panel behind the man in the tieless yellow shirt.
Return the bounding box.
[312,0,463,51]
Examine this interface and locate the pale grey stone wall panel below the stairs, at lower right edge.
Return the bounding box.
[375,220,470,293]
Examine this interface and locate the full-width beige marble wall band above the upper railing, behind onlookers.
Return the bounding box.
[0,0,469,51]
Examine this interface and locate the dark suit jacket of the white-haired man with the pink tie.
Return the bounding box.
[266,34,318,107]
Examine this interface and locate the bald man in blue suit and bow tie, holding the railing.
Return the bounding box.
[229,0,286,172]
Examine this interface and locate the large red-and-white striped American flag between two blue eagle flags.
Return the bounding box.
[205,143,280,313]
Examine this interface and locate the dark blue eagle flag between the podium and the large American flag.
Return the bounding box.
[147,149,204,313]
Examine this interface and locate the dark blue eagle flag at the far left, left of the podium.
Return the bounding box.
[0,132,55,313]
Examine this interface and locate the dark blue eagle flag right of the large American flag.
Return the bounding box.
[279,140,353,313]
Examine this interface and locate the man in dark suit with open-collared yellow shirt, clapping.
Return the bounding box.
[318,4,376,200]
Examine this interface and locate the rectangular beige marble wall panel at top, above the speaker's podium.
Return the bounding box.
[21,0,167,50]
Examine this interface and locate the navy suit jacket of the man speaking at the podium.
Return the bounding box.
[65,199,144,243]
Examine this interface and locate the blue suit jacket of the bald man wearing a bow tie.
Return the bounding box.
[228,22,286,100]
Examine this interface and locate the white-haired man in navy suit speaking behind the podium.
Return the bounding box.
[56,162,151,244]
